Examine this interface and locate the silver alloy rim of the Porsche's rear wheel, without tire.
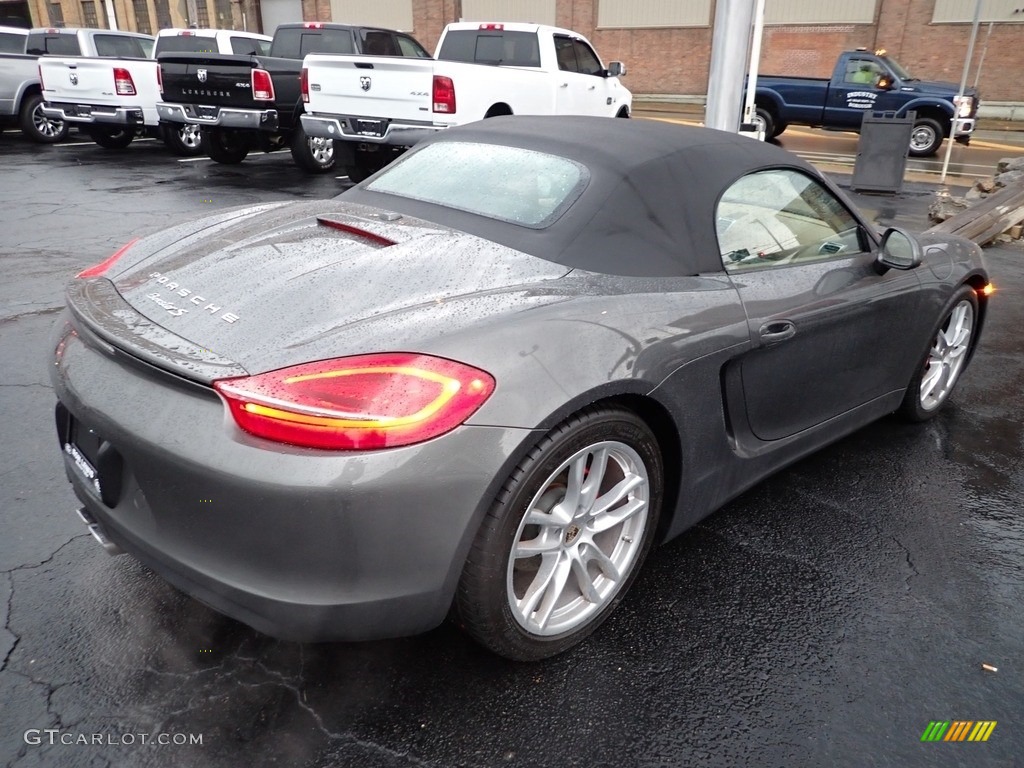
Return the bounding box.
[506,440,650,636]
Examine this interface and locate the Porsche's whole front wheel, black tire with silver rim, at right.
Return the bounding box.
[899,286,979,422]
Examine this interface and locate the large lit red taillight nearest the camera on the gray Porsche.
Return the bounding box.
[213,352,495,451]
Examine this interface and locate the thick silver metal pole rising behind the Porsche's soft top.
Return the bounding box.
[705,0,755,133]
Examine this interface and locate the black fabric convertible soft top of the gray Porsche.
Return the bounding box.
[342,116,839,276]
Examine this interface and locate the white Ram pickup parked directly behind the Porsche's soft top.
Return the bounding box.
[302,23,633,181]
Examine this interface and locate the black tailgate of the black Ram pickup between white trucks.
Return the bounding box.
[157,53,261,108]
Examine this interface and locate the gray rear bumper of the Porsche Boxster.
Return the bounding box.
[52,313,530,642]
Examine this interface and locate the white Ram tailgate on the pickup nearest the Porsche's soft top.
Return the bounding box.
[303,54,436,121]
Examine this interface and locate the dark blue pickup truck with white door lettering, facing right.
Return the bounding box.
[755,49,978,157]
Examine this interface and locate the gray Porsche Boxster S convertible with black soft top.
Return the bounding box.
[52,118,990,659]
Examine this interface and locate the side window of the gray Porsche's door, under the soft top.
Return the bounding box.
[715,168,864,271]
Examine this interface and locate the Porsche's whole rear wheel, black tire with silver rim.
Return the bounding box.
[455,407,664,662]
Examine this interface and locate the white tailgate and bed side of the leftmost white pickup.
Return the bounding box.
[39,56,157,106]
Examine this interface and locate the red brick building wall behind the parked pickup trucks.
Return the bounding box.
[18,0,1024,103]
